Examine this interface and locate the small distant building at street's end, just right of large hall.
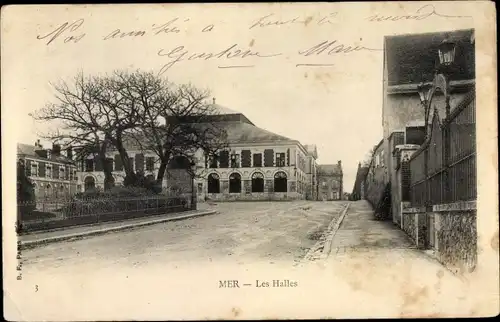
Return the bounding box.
[317,161,344,201]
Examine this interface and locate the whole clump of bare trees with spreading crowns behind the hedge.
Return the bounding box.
[34,71,227,188]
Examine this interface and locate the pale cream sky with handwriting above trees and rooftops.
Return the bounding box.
[2,2,473,192]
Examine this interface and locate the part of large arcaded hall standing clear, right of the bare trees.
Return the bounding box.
[196,106,317,201]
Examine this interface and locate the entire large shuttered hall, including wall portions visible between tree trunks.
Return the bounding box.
[71,103,317,201]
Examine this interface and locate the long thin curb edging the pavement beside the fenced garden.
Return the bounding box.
[19,210,219,249]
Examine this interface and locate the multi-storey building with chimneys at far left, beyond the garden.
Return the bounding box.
[17,140,79,200]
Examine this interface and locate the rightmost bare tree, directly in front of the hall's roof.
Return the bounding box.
[129,78,227,184]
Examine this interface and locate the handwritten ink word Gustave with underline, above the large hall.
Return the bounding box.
[158,44,281,75]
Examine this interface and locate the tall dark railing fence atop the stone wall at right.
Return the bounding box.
[409,91,477,207]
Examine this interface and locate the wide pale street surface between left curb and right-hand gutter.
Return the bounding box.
[23,201,346,274]
